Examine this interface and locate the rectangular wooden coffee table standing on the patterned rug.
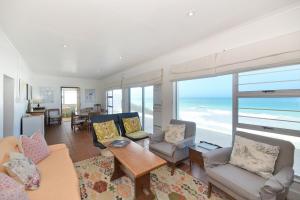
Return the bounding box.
[108,141,167,200]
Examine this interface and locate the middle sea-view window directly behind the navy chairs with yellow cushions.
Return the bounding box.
[130,86,153,133]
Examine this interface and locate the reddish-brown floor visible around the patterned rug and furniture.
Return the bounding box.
[45,121,207,182]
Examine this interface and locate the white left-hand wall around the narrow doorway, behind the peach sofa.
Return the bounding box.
[0,29,31,137]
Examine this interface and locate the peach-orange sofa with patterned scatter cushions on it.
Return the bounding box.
[0,137,80,200]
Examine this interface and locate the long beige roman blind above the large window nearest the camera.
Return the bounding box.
[170,32,300,81]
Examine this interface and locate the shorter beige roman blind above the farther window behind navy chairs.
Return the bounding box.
[122,69,163,88]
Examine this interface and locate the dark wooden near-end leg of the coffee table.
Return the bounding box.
[134,173,154,200]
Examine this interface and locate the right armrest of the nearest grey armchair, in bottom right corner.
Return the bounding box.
[260,167,294,199]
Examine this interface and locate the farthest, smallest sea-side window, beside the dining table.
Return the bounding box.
[106,89,122,114]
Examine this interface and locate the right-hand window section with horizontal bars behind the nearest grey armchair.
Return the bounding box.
[236,65,300,175]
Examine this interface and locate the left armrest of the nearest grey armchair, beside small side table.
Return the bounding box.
[202,147,232,167]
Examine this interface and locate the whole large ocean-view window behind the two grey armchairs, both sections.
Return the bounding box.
[176,65,300,176]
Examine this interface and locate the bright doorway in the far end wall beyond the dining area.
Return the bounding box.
[61,87,80,121]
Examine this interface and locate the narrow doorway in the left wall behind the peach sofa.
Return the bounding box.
[3,75,15,137]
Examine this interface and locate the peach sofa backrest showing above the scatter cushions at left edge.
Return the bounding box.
[0,136,19,172]
